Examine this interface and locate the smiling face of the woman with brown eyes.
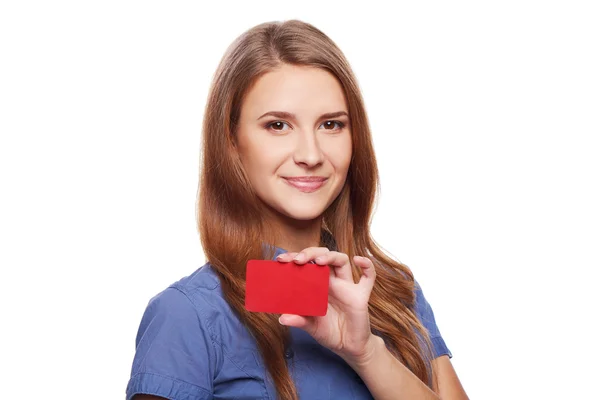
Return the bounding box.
[236,64,352,220]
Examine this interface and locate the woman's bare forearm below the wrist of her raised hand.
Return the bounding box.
[349,335,440,400]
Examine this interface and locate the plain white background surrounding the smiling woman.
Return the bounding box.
[0,1,600,399]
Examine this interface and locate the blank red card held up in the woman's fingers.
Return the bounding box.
[246,260,329,316]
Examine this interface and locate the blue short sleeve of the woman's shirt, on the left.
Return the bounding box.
[126,287,216,400]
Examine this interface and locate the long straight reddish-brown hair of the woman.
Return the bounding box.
[197,20,433,400]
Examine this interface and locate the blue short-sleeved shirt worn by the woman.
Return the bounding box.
[126,247,452,400]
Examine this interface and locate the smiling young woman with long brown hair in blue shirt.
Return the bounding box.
[127,20,467,400]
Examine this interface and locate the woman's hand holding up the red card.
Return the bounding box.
[277,247,377,364]
